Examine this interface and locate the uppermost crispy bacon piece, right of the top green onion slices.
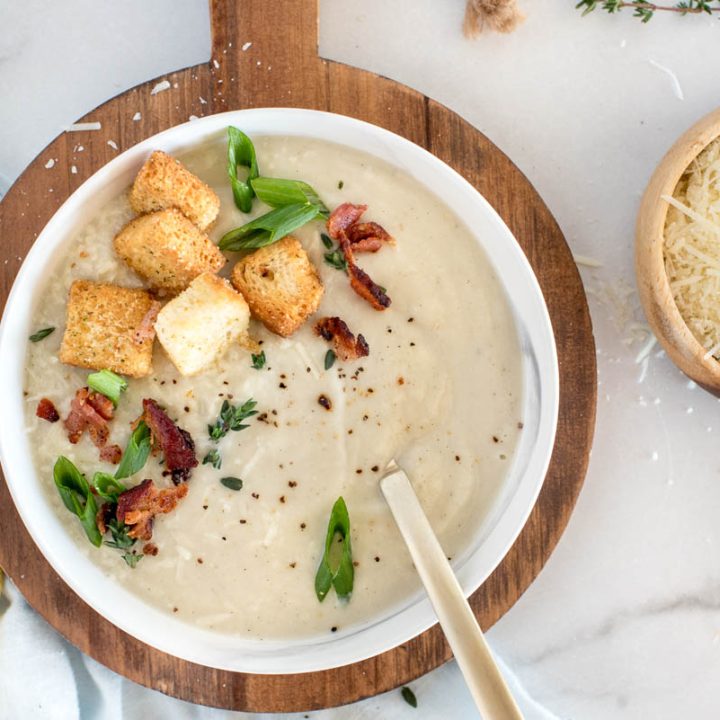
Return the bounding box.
[327,203,393,310]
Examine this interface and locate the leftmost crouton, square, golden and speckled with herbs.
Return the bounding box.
[60,280,155,377]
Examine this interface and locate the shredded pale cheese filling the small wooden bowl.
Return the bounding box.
[663,140,720,359]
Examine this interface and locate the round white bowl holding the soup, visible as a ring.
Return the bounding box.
[0,108,559,673]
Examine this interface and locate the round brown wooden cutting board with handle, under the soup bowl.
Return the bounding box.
[0,0,597,712]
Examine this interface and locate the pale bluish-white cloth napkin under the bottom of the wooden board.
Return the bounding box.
[0,579,559,720]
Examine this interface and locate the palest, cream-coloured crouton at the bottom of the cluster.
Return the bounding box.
[155,273,250,375]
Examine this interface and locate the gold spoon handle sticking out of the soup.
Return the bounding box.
[380,464,523,720]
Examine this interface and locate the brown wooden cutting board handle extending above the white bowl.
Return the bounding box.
[210,0,323,109]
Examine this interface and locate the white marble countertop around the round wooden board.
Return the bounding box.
[0,0,720,720]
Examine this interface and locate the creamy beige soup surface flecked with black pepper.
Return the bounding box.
[25,136,522,639]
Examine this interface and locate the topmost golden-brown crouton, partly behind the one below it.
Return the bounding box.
[130,150,220,230]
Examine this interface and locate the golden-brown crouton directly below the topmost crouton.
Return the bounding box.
[114,209,226,295]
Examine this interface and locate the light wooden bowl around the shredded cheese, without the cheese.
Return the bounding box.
[635,109,720,395]
